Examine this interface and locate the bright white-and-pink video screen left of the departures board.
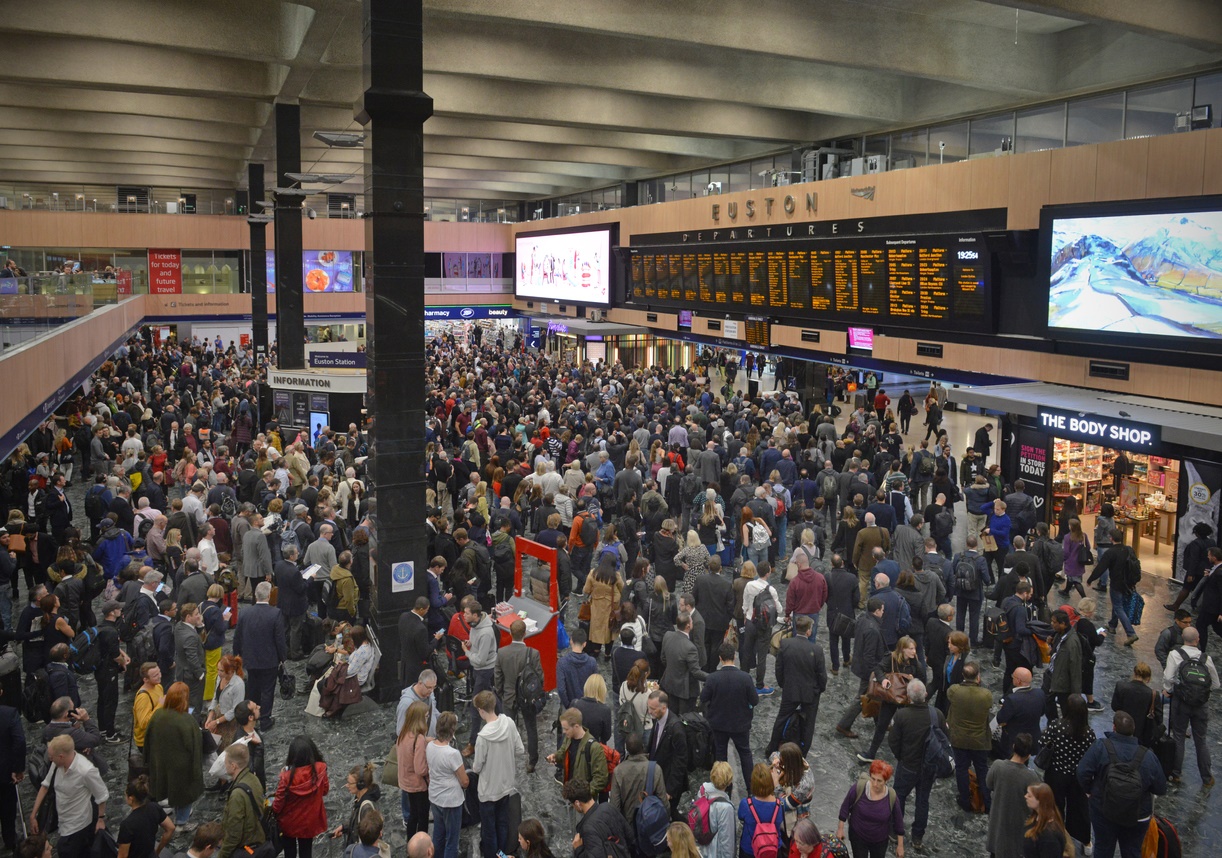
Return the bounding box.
[513,229,612,307]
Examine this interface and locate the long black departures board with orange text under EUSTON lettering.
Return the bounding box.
[623,232,993,332]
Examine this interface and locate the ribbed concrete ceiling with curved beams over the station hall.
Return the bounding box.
[0,0,1222,199]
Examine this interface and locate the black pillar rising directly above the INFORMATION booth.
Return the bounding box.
[275,104,306,369]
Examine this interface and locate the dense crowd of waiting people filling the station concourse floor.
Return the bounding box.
[0,327,1222,858]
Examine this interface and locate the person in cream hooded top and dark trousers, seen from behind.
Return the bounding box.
[470,689,525,858]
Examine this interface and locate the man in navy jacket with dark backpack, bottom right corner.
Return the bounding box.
[1078,711,1167,858]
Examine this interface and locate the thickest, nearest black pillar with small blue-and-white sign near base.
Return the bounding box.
[357,0,433,699]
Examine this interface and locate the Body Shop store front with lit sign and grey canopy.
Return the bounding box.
[953,384,1222,578]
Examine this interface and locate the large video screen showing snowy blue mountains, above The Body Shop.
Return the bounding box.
[1046,210,1222,340]
